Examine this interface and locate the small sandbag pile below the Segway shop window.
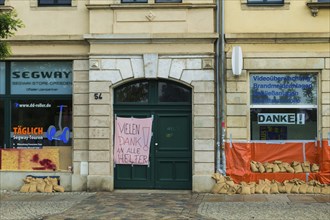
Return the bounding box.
[20,176,64,193]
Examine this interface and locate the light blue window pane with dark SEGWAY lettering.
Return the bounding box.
[11,62,72,95]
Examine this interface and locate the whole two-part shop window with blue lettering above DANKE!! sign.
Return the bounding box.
[250,73,317,140]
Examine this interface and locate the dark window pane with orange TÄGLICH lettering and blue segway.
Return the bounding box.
[10,100,72,148]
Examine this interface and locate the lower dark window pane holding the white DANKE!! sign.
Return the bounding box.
[250,109,317,140]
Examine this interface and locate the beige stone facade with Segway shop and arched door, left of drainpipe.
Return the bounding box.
[0,0,218,191]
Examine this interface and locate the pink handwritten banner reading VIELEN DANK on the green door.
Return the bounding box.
[114,117,152,165]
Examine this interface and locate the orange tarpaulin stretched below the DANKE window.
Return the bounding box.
[225,141,330,184]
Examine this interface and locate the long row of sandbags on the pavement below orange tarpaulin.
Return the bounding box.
[211,173,330,195]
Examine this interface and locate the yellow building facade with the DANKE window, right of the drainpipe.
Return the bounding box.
[225,0,330,144]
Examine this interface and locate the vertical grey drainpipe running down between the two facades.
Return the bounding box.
[215,0,226,175]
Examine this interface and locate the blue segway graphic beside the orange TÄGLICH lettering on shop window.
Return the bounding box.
[47,105,70,144]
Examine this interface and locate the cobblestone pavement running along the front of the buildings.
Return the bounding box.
[0,190,330,220]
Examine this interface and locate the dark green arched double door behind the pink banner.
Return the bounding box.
[114,80,192,189]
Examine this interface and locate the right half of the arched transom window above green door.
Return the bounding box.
[158,82,190,102]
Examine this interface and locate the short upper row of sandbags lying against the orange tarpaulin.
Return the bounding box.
[250,160,320,173]
